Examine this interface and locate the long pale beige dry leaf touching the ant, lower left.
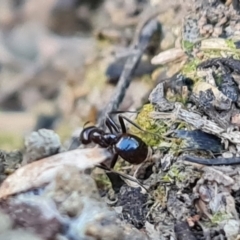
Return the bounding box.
[0,148,112,199]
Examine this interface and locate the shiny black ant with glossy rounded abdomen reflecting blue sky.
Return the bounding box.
[80,112,152,168]
